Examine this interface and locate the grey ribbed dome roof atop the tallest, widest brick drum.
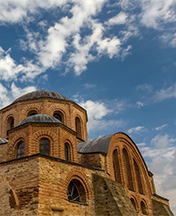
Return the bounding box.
[13,90,70,103]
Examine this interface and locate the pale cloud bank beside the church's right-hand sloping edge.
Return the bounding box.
[139,134,176,214]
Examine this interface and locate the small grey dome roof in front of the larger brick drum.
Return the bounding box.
[18,114,63,126]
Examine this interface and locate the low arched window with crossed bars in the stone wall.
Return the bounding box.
[67,179,86,203]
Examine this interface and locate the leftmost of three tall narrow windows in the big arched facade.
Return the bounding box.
[113,149,122,184]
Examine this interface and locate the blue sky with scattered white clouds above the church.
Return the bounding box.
[0,0,176,214]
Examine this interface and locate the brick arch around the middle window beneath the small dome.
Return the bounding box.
[32,129,57,156]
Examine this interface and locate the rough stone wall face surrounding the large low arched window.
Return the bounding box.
[39,157,105,216]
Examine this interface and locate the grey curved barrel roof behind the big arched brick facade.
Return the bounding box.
[77,134,114,154]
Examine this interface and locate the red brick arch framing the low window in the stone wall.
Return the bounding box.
[63,169,92,200]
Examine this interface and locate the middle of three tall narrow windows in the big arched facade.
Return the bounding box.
[123,148,134,190]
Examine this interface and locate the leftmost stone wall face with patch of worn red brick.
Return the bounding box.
[0,157,39,216]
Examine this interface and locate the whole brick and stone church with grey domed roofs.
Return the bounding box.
[0,90,173,216]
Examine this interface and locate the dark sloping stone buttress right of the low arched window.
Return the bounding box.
[93,174,137,216]
